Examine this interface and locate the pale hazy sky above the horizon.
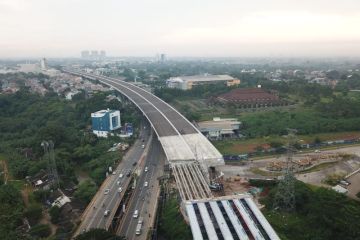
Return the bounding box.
[0,0,360,58]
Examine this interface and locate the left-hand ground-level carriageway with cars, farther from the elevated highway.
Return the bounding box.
[74,123,152,236]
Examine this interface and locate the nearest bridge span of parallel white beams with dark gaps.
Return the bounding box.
[185,195,280,240]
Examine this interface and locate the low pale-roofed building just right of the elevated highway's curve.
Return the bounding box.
[196,117,241,140]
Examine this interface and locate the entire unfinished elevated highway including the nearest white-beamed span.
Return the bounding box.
[63,69,279,240]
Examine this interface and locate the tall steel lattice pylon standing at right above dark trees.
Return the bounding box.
[274,129,296,212]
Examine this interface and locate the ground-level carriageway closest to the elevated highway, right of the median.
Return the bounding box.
[117,135,165,240]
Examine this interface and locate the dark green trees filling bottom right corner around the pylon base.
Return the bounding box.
[262,181,360,240]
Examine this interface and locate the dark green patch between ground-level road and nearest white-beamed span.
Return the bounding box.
[159,197,192,240]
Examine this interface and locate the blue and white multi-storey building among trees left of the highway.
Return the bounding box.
[91,109,121,137]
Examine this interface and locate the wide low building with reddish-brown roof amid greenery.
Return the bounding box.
[217,88,285,108]
